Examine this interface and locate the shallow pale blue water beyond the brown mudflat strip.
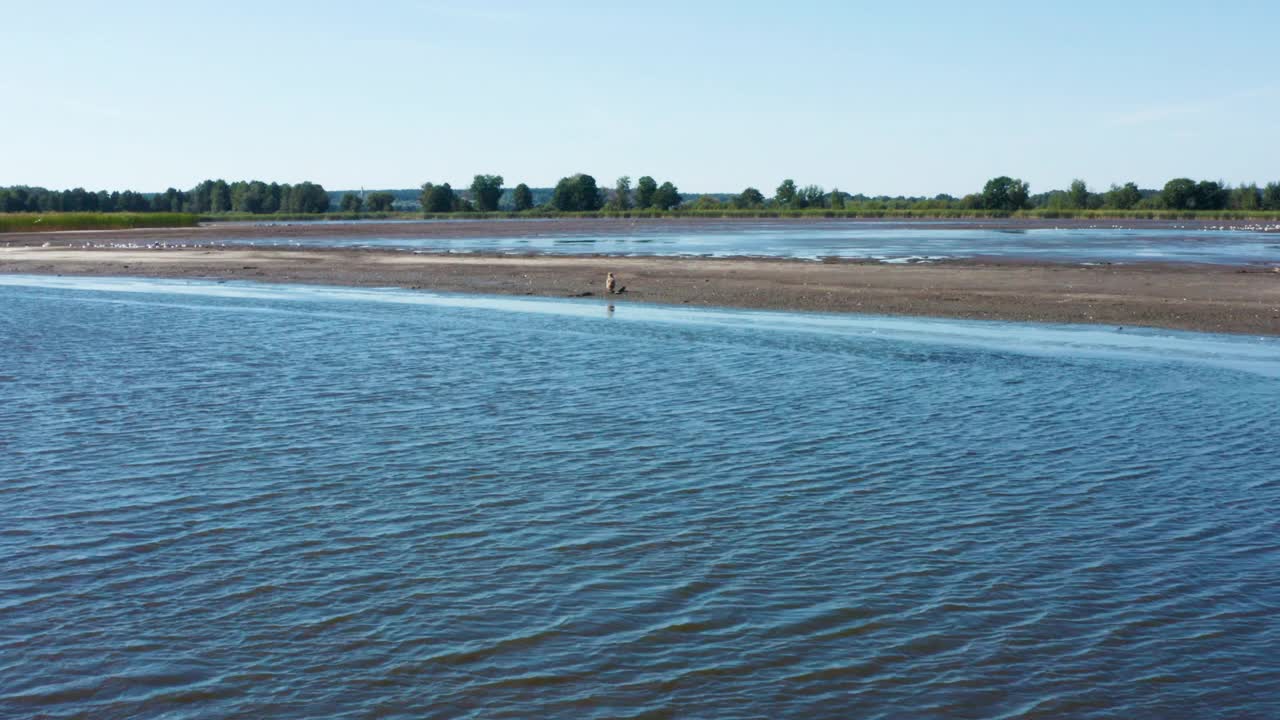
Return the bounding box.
[209,220,1280,265]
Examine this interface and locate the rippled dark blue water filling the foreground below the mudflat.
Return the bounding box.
[0,275,1280,719]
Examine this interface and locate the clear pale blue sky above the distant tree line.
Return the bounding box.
[0,0,1280,195]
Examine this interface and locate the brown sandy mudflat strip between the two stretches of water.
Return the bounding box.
[0,239,1280,336]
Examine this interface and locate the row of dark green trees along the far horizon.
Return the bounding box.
[0,173,1280,215]
